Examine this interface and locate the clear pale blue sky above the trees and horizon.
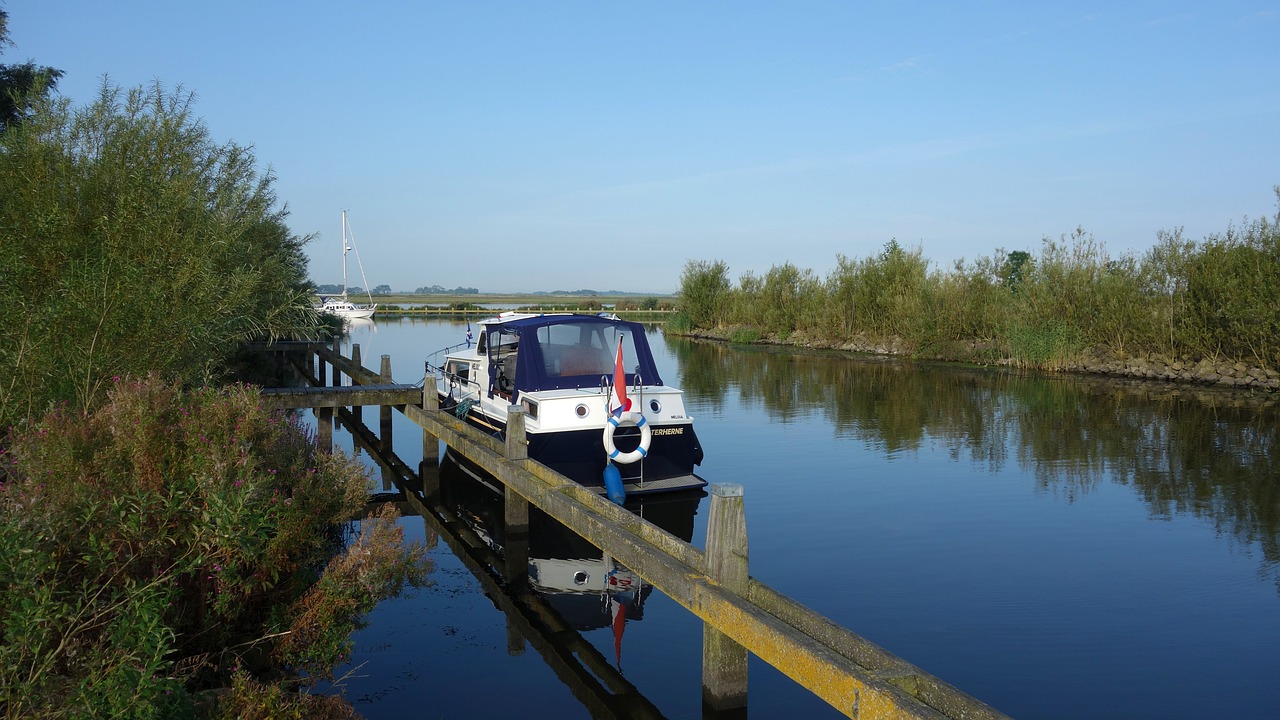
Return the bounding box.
[10,0,1280,292]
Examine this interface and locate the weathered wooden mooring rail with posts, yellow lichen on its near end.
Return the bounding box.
[264,343,1006,720]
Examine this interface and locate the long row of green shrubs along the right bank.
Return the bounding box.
[672,187,1280,369]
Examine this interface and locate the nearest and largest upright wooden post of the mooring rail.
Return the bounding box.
[703,483,750,712]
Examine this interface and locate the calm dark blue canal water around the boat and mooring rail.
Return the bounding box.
[309,319,1280,719]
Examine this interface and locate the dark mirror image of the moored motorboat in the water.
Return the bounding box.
[439,450,707,638]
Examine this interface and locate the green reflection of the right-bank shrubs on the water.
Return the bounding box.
[667,338,1280,589]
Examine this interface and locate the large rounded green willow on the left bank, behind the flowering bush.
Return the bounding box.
[0,82,315,425]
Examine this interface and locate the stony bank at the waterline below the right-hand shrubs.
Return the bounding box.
[666,328,1280,393]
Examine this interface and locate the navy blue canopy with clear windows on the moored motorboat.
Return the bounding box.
[485,315,662,391]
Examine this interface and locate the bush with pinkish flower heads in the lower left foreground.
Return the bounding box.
[0,379,426,717]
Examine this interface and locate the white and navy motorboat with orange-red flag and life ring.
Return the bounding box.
[426,311,707,501]
